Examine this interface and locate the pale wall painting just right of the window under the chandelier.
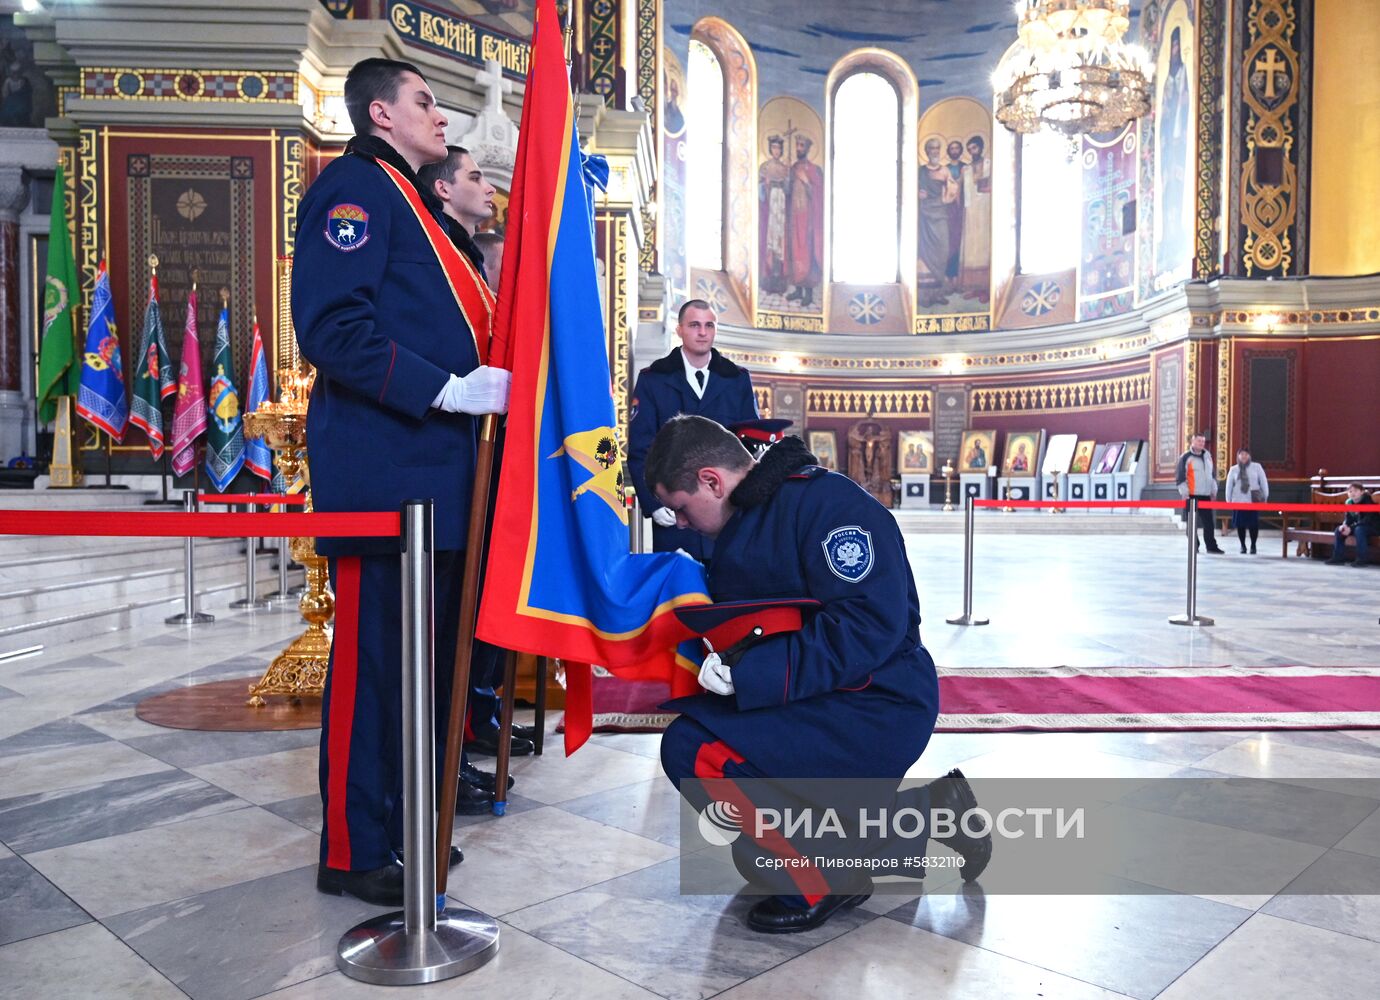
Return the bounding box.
[1078,123,1140,320]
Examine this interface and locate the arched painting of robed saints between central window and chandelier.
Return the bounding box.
[916,98,992,332]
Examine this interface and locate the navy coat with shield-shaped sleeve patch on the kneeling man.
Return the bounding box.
[668,460,938,778]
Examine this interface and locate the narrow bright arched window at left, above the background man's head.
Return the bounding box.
[686,39,723,270]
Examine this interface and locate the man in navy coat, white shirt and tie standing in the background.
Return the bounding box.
[628,298,758,563]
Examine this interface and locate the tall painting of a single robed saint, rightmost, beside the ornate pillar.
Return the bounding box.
[1147,0,1196,291]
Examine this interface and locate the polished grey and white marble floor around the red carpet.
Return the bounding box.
[0,532,1380,1000]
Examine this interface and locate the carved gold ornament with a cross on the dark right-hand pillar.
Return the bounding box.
[1241,0,1300,277]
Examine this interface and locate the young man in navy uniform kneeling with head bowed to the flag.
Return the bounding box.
[646,417,991,934]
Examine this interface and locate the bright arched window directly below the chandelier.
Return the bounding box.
[1018,131,1083,274]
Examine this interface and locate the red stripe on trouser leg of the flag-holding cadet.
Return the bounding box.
[326,556,360,870]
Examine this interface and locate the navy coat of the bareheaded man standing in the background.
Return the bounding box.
[628,348,758,561]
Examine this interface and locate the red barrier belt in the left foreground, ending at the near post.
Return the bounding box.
[0,510,402,538]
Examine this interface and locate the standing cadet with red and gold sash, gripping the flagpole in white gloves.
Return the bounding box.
[293,59,509,906]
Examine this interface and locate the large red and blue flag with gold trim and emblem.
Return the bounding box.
[479,0,708,752]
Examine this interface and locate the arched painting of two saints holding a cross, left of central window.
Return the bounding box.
[758,97,825,330]
